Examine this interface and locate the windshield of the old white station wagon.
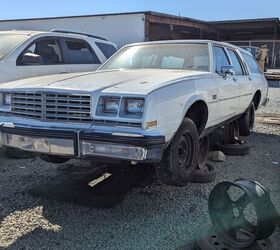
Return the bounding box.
[100,44,210,71]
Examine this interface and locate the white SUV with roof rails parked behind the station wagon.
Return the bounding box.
[0,30,117,83]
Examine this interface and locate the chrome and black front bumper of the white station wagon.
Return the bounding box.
[0,124,165,162]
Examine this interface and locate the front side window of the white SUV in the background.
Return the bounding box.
[17,38,62,65]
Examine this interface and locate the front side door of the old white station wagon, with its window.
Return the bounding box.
[214,45,240,122]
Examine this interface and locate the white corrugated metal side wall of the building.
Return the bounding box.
[0,13,145,48]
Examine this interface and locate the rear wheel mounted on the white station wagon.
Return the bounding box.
[238,102,256,136]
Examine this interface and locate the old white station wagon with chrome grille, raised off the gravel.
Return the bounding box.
[0,40,268,185]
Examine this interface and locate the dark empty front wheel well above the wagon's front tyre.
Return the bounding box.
[185,101,208,135]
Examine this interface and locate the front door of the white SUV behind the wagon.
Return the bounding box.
[17,37,71,79]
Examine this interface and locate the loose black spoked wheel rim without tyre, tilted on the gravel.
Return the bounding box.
[209,180,278,248]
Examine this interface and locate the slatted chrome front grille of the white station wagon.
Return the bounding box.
[11,92,92,122]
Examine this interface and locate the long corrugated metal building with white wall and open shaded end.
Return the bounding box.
[0,11,217,47]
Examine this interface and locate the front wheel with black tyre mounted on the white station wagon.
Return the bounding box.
[155,118,199,186]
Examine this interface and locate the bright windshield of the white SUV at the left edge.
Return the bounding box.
[0,34,27,59]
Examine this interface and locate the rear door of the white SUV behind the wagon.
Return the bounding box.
[61,38,101,72]
